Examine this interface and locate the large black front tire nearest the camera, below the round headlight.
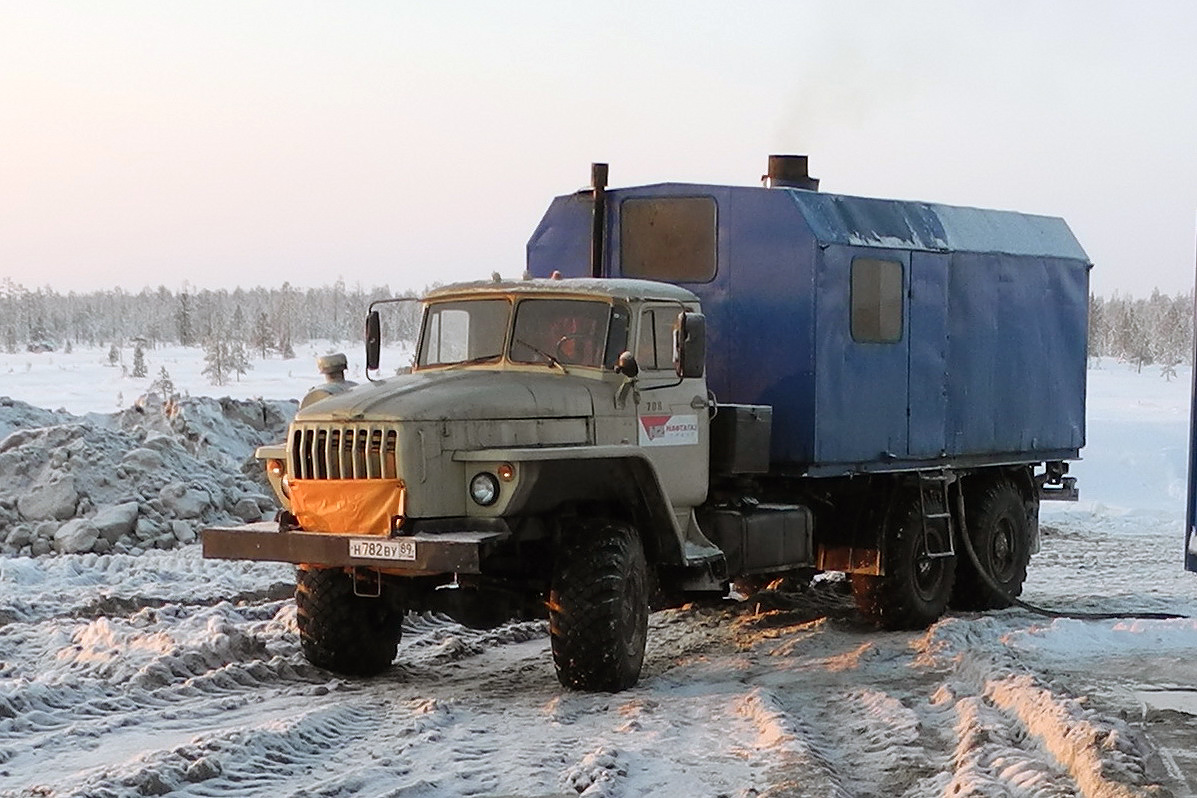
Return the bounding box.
[548,523,649,693]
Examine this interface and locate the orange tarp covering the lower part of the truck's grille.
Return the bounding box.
[291,480,407,535]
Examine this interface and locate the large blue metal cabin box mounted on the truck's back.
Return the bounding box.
[528,183,1092,476]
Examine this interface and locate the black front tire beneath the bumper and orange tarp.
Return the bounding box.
[296,567,403,676]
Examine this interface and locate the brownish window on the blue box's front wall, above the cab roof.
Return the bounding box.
[619,196,716,282]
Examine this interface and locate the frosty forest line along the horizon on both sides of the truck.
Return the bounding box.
[0,278,1193,372]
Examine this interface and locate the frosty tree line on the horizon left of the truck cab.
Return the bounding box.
[0,278,418,360]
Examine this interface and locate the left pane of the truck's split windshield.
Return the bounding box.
[417,299,511,366]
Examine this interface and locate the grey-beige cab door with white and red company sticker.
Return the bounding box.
[634,303,710,510]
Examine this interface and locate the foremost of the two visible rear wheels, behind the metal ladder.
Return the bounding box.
[852,493,956,629]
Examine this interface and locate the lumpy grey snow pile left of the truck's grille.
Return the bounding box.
[0,394,297,556]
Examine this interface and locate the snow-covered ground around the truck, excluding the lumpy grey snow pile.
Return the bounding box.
[0,346,1197,798]
